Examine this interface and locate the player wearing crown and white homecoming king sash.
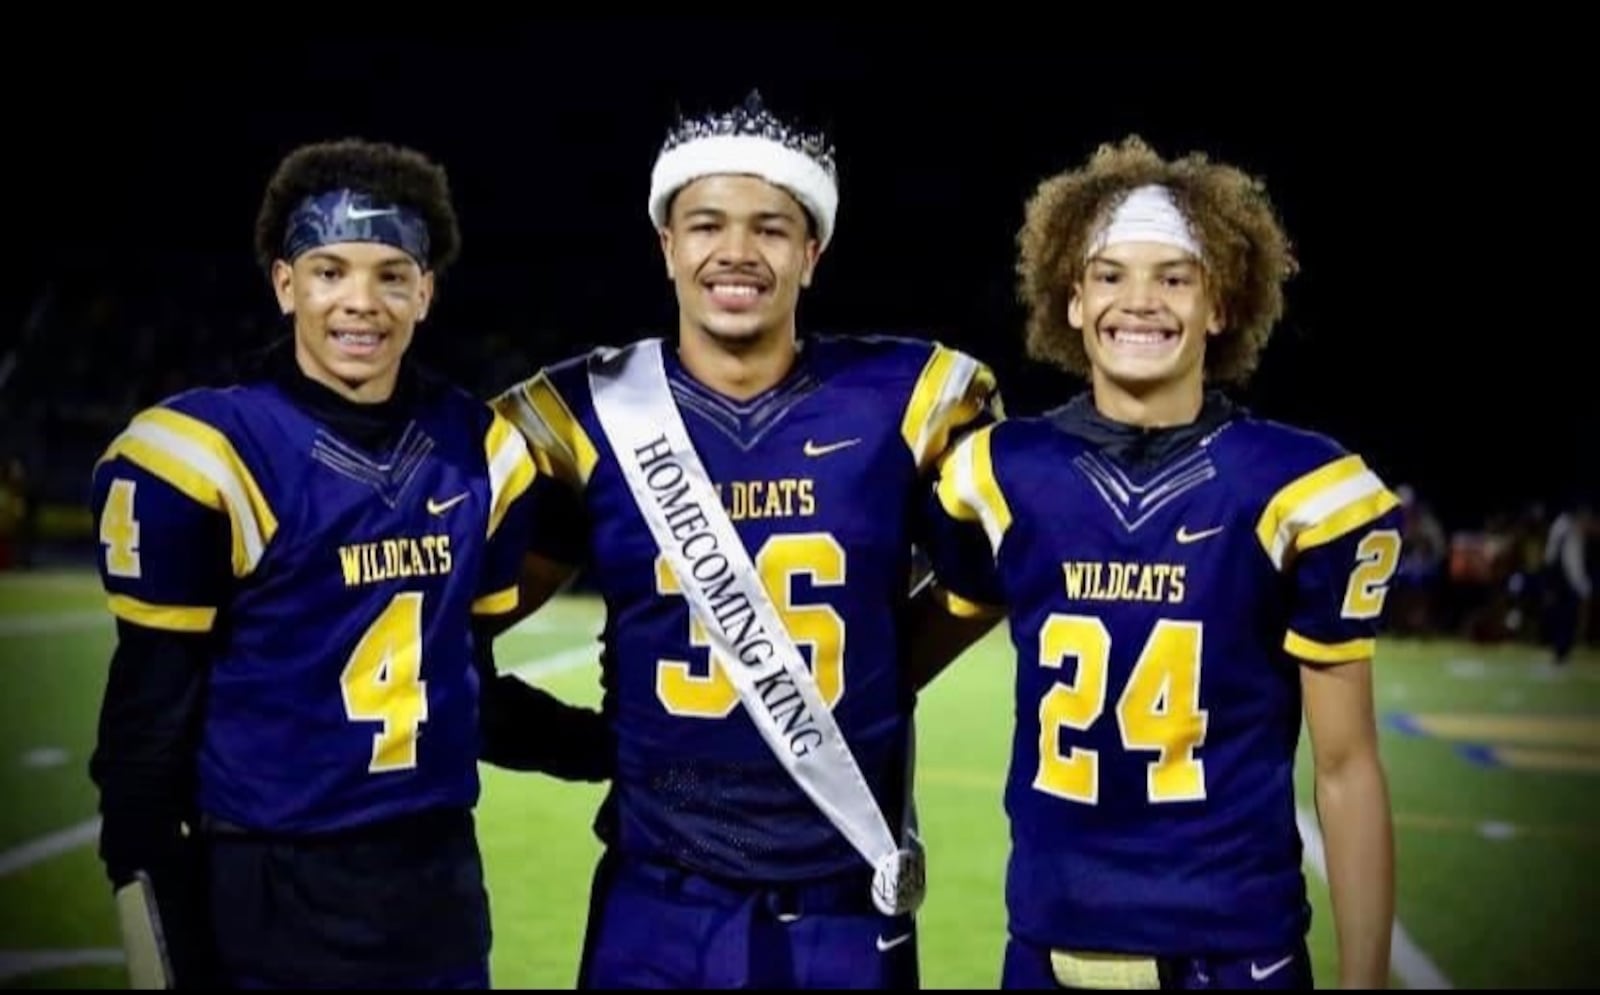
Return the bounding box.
[498,94,998,989]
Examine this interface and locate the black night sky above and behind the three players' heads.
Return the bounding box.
[9,21,1600,531]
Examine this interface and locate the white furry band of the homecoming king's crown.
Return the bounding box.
[650,134,838,248]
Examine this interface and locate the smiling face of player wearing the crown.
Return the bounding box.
[661,176,821,349]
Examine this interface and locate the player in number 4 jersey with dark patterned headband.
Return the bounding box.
[91,141,606,987]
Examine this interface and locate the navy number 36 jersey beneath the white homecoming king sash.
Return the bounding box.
[496,336,998,881]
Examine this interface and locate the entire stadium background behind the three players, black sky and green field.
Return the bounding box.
[0,21,1600,987]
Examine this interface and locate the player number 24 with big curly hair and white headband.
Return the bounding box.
[936,138,1400,989]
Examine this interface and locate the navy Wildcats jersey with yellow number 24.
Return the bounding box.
[938,413,1400,955]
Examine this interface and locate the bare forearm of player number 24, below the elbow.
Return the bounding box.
[1317,753,1395,989]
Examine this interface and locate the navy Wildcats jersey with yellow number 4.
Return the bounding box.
[93,374,536,833]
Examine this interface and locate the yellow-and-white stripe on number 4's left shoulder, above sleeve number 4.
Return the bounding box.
[101,408,278,577]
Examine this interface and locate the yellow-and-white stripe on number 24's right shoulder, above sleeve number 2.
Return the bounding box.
[1256,454,1400,569]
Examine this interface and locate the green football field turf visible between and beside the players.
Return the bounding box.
[0,573,1600,989]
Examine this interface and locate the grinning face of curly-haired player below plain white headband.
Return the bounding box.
[1067,242,1222,422]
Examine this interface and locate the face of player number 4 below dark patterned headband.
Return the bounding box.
[272,242,434,403]
